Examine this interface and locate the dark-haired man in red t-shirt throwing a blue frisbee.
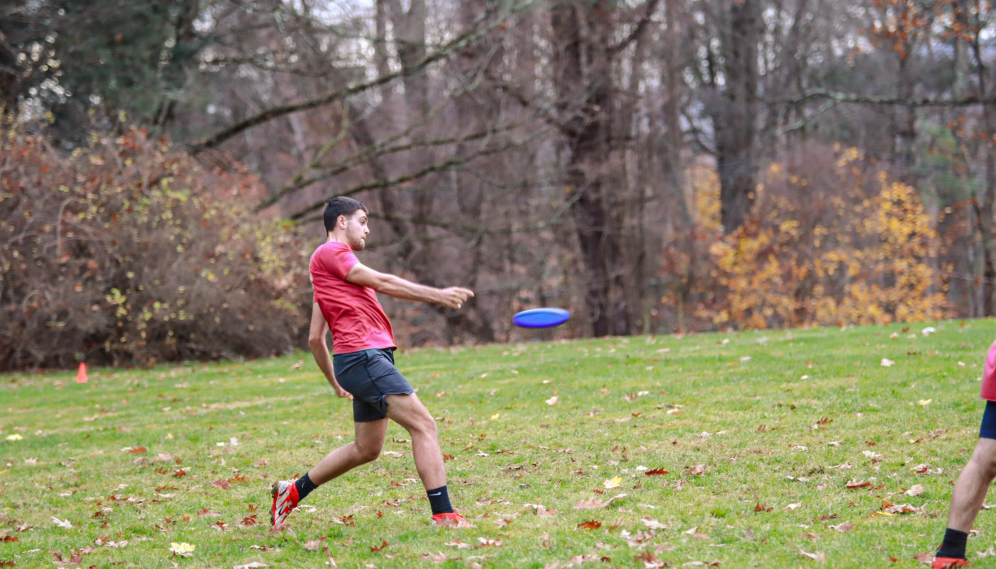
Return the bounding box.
[270,197,474,527]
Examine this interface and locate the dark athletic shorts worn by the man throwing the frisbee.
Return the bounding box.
[332,348,415,423]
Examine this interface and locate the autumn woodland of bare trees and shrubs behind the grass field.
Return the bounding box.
[0,0,996,370]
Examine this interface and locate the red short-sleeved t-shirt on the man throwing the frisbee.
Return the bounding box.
[310,241,396,354]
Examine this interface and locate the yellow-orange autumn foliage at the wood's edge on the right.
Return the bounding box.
[684,144,948,328]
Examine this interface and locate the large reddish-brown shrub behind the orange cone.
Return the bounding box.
[0,120,309,370]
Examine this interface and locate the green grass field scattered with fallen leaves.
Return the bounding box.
[0,321,996,568]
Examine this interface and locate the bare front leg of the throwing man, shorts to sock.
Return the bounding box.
[387,393,446,491]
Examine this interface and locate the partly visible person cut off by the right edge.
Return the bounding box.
[931,342,996,569]
